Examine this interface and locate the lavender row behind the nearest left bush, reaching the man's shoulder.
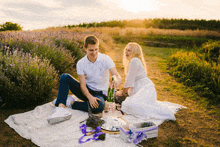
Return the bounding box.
[0,32,76,75]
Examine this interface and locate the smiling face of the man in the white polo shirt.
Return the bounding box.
[86,43,99,62]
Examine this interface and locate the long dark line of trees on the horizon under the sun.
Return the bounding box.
[63,18,220,31]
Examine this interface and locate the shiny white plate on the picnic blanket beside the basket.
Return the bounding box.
[101,117,127,132]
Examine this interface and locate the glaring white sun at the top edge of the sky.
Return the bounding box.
[121,0,155,13]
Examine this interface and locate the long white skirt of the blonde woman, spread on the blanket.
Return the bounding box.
[121,78,183,120]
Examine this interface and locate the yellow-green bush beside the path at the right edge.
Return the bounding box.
[168,51,220,99]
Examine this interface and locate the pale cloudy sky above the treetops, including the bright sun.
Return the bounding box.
[0,0,220,30]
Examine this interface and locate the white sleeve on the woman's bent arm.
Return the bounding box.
[124,58,139,88]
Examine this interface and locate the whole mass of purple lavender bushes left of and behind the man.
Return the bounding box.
[0,29,115,108]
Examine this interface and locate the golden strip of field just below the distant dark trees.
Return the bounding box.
[48,27,220,38]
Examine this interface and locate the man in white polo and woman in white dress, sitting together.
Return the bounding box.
[47,35,175,124]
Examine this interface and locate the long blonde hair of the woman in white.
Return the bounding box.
[123,42,147,75]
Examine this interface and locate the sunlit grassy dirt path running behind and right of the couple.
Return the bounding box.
[106,46,220,147]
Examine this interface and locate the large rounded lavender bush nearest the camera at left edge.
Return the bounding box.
[0,50,58,108]
